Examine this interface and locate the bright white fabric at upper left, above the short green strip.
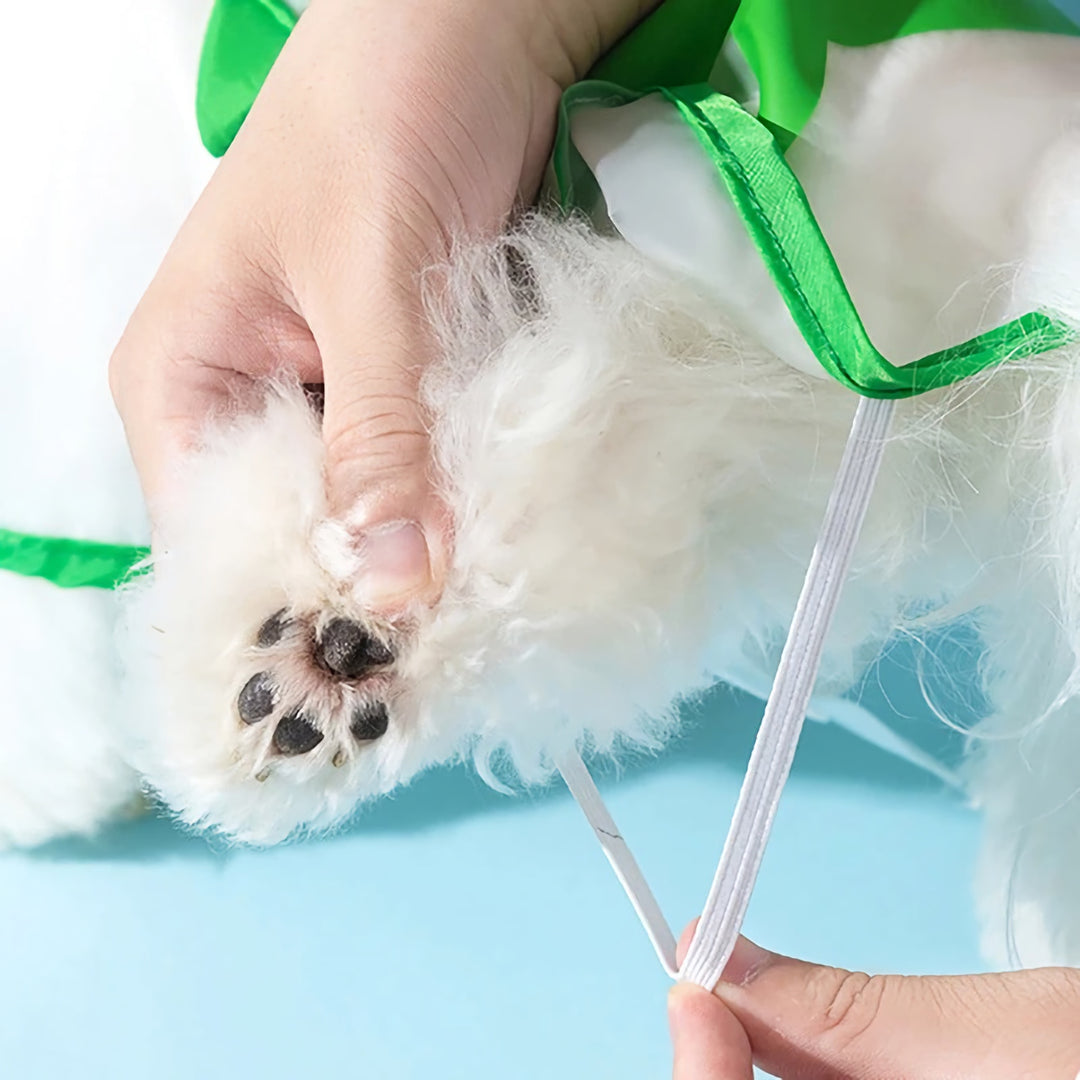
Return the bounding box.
[0,0,213,543]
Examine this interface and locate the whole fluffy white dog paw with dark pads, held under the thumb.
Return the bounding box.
[117,388,432,843]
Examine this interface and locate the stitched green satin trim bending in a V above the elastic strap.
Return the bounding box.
[553,82,1077,397]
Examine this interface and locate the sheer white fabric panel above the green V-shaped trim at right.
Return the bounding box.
[787,31,1080,364]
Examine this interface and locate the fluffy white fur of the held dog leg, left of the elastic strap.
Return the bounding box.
[122,227,851,841]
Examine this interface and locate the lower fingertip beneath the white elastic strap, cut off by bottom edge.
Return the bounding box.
[667,983,754,1080]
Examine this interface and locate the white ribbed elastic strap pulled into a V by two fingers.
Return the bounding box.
[559,397,893,988]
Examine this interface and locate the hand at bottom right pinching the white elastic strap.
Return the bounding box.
[669,932,1080,1080]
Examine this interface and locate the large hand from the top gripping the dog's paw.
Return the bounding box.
[110,0,656,612]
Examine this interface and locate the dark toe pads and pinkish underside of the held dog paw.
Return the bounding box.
[235,608,395,783]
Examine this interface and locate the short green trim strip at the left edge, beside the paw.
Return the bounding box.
[0,529,150,589]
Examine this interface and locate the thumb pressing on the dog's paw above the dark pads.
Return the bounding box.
[310,248,448,613]
